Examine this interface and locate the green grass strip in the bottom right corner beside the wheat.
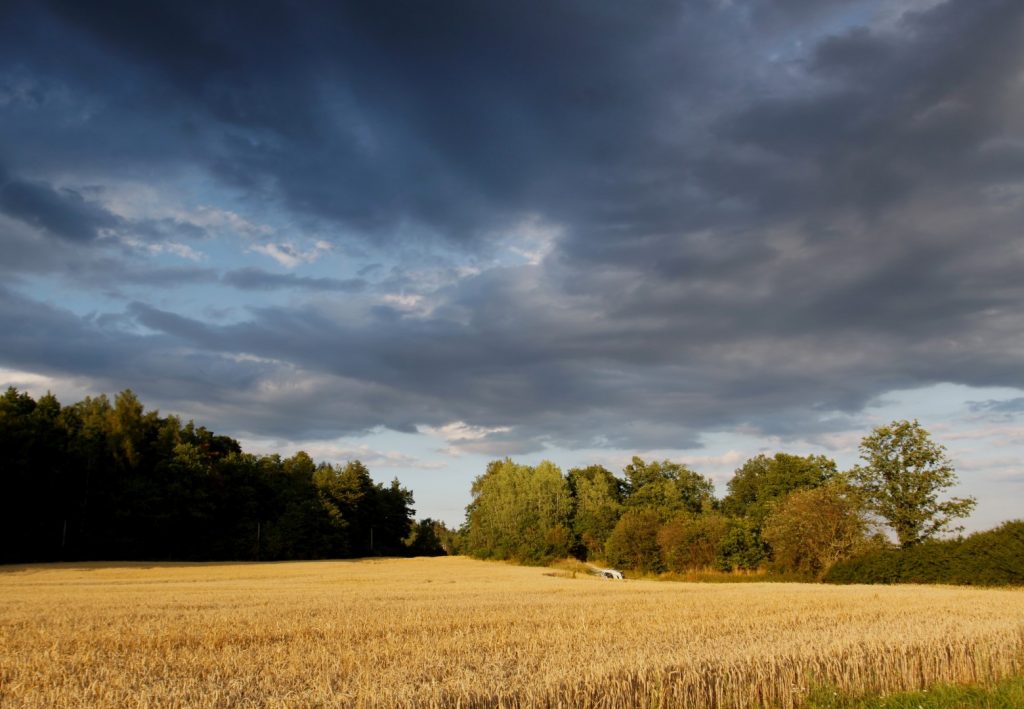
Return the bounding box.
[807,676,1024,709]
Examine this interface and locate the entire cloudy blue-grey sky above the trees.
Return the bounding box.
[0,0,1024,530]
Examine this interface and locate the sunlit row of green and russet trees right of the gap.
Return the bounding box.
[459,421,991,578]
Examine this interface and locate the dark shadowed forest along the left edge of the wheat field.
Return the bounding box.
[0,388,443,562]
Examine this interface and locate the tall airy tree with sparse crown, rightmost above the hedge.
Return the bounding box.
[853,420,975,548]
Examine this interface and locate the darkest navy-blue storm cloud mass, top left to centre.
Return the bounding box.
[7,2,729,238]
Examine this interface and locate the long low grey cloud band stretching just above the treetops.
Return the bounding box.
[112,252,1024,452]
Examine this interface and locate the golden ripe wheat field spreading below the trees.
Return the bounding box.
[0,558,1024,707]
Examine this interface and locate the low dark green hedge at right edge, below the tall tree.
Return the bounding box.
[824,520,1024,586]
